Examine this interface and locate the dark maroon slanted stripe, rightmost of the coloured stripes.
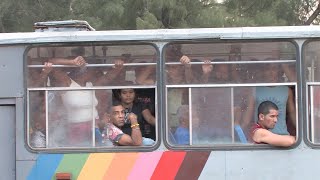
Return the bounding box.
[175,151,210,180]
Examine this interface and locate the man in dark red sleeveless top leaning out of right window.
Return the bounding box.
[251,101,295,147]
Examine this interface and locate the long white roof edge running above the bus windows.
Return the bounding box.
[0,26,320,45]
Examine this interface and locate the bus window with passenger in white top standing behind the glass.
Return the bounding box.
[26,43,159,149]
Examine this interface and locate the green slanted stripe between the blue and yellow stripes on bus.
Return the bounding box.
[52,154,89,180]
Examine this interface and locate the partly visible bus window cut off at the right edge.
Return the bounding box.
[303,41,320,145]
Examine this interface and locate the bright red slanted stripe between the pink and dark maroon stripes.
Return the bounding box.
[151,151,186,180]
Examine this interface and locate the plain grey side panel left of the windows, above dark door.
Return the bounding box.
[0,46,25,98]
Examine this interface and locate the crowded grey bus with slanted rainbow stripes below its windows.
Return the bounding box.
[0,22,320,180]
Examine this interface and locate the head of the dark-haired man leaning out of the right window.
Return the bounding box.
[258,101,279,129]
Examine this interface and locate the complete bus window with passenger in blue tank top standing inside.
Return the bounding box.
[163,42,297,148]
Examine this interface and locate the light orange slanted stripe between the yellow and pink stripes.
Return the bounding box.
[103,153,139,180]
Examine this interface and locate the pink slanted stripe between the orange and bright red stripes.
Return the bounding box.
[128,151,163,180]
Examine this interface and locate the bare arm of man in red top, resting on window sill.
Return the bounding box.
[252,129,296,147]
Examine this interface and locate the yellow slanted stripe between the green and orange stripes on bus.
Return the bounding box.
[77,153,114,180]
